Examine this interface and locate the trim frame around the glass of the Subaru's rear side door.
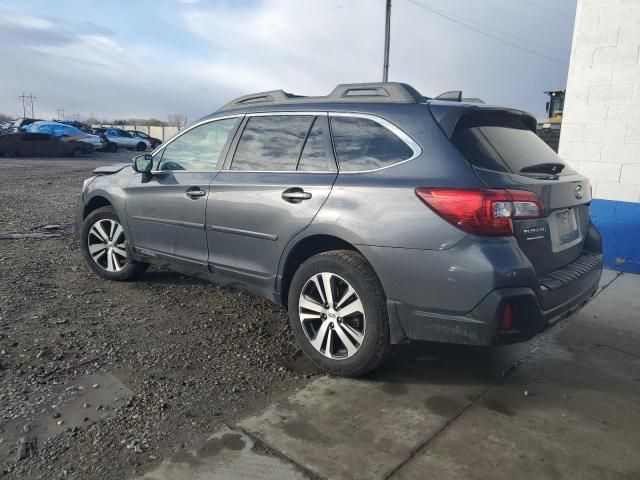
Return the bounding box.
[221,111,338,175]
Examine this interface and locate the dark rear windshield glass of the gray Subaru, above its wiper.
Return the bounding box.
[451,113,575,175]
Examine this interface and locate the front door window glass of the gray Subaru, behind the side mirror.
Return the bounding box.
[159,118,238,171]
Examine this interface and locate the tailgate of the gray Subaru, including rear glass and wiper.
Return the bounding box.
[442,108,591,275]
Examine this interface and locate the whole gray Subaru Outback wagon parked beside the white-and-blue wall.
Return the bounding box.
[76,83,602,376]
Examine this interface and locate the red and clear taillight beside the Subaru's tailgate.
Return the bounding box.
[416,188,544,236]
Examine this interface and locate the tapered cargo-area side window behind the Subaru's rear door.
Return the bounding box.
[331,116,413,172]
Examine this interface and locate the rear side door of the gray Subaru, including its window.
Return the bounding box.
[206,113,337,291]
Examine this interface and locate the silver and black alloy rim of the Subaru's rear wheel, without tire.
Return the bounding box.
[298,272,366,360]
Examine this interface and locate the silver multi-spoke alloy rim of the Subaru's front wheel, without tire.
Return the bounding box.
[87,218,127,272]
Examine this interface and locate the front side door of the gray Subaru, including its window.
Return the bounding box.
[126,117,240,270]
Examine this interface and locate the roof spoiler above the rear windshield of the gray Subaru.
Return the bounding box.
[429,102,538,138]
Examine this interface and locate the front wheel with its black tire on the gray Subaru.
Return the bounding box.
[80,207,149,281]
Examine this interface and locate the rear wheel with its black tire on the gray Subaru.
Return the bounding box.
[288,250,391,377]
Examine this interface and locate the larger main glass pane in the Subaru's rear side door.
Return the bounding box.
[231,115,314,171]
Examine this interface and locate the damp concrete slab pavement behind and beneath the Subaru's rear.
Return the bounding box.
[138,271,640,480]
